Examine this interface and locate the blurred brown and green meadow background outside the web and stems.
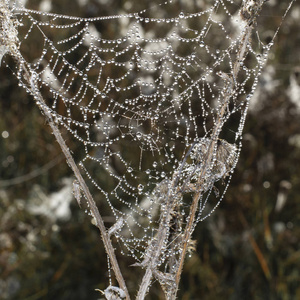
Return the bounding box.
[0,0,300,300]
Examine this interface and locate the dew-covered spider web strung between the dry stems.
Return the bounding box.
[2,0,271,264]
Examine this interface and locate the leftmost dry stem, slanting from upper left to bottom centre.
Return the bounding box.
[0,0,130,300]
